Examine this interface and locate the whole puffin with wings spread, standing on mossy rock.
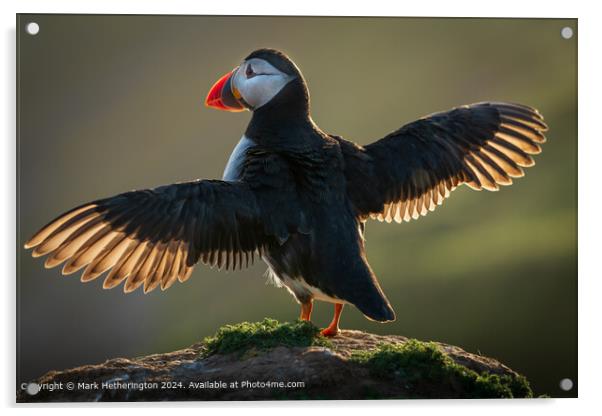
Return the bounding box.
[25,48,547,336]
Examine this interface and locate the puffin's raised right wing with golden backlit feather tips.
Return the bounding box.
[355,102,547,222]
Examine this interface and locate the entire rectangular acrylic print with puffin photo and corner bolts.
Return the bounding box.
[16,14,578,402]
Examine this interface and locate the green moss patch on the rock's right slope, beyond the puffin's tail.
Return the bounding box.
[351,339,533,398]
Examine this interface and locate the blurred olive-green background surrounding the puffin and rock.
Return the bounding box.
[17,15,577,397]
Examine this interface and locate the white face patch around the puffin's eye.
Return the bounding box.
[232,58,294,110]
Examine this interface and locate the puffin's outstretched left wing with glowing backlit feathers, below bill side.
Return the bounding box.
[25,180,270,292]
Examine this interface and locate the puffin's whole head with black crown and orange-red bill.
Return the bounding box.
[205,49,309,116]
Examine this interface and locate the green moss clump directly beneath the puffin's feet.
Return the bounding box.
[201,318,332,357]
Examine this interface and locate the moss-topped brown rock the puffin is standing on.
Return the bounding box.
[17,319,532,402]
